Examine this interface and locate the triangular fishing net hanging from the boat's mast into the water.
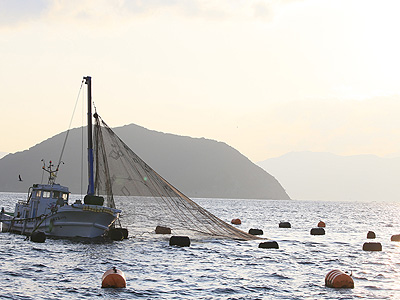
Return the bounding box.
[94,113,258,240]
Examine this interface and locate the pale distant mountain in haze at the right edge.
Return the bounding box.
[258,152,400,201]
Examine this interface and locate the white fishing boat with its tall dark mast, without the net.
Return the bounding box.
[0,76,121,238]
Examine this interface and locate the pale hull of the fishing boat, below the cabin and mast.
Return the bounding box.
[1,204,120,238]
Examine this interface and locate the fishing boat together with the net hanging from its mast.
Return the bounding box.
[0,76,259,240]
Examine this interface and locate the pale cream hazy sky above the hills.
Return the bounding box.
[0,0,400,162]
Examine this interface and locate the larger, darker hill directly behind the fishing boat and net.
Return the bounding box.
[0,124,289,199]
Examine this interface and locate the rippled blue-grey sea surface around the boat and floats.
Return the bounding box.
[0,193,400,299]
